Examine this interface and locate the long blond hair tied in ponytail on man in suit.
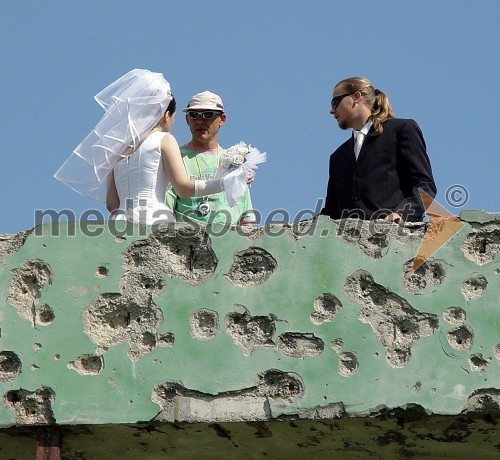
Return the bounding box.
[335,77,396,136]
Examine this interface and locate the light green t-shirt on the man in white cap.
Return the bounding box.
[165,144,254,225]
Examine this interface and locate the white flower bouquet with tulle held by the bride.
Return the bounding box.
[217,142,267,206]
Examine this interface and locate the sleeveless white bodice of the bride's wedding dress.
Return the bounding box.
[111,131,175,225]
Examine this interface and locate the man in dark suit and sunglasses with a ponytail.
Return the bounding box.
[321,77,437,222]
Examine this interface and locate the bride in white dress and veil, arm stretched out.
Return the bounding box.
[54,69,253,225]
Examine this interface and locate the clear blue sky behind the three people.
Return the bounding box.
[0,0,500,233]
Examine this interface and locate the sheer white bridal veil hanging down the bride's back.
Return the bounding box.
[54,69,172,201]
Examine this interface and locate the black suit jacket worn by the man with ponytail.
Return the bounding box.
[321,118,437,222]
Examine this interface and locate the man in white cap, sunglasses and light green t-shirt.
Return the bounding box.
[165,91,255,225]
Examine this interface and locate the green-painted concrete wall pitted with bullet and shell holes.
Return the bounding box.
[0,211,500,427]
